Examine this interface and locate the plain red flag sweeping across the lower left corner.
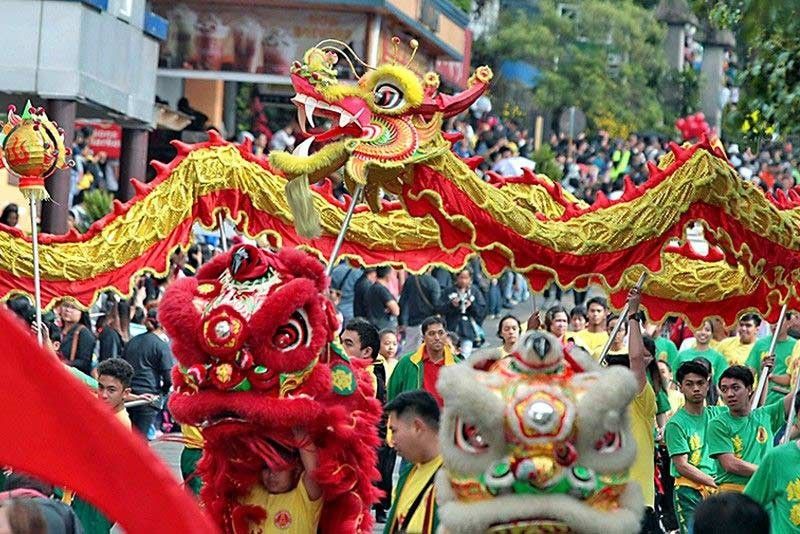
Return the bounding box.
[0,309,218,534]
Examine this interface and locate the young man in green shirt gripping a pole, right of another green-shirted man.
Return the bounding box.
[708,366,791,493]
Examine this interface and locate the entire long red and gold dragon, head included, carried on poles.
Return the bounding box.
[0,46,800,324]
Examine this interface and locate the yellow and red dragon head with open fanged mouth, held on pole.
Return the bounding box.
[270,41,492,211]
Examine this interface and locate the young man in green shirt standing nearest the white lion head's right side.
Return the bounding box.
[664,361,725,534]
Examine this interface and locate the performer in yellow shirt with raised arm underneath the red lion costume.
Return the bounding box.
[242,429,322,534]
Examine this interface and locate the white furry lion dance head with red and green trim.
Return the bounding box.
[437,331,642,534]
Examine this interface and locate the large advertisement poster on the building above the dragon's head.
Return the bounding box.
[153,2,367,75]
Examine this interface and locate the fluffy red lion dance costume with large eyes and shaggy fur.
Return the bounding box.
[159,245,381,533]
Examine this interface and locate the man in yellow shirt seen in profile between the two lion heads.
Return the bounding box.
[383,390,442,534]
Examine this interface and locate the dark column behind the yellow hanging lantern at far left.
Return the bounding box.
[42,99,78,234]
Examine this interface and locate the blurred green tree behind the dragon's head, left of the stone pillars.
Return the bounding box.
[475,0,674,137]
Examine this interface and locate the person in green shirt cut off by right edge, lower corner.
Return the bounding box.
[744,396,800,534]
